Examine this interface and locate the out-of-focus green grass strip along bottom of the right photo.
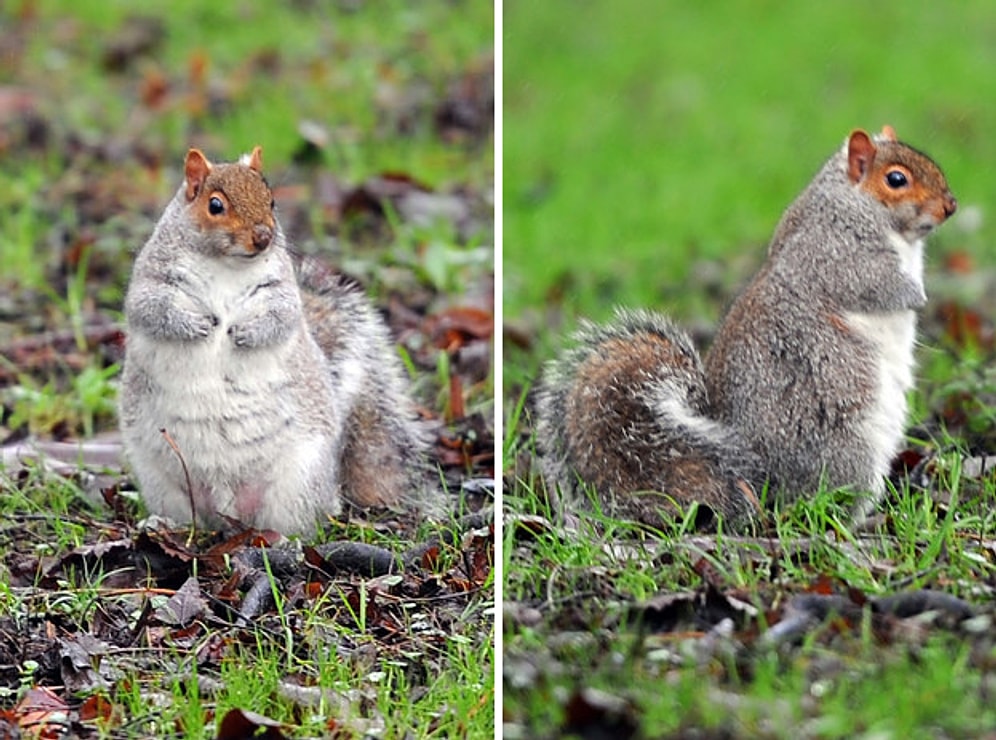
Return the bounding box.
[505,640,994,738]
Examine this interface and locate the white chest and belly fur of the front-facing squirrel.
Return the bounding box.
[125,254,341,532]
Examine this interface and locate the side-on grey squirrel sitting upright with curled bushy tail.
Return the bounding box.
[536,126,957,530]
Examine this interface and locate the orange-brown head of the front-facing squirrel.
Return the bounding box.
[184,146,277,257]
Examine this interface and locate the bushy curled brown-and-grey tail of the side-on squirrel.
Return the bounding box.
[536,309,760,527]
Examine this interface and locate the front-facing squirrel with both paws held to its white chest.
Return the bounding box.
[120,147,427,534]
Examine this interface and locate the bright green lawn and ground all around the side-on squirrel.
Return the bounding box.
[502,0,996,737]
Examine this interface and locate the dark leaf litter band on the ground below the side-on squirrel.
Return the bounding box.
[503,516,996,738]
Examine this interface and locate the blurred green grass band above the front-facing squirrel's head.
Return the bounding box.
[6,0,493,185]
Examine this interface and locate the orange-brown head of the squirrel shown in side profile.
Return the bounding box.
[846,126,958,242]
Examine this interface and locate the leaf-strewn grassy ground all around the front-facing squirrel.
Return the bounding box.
[0,0,494,738]
